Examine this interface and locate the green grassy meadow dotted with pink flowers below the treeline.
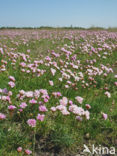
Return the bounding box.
[0,29,117,156]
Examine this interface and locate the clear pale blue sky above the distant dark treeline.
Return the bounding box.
[0,0,117,28]
